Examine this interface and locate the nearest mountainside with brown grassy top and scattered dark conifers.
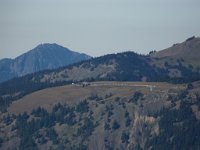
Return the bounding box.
[0,81,200,150]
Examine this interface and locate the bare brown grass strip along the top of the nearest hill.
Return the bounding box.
[8,81,183,113]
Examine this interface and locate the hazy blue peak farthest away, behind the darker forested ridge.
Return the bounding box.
[0,44,91,82]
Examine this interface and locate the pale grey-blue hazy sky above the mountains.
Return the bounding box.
[0,0,200,58]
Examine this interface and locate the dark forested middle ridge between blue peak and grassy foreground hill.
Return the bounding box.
[0,38,200,102]
